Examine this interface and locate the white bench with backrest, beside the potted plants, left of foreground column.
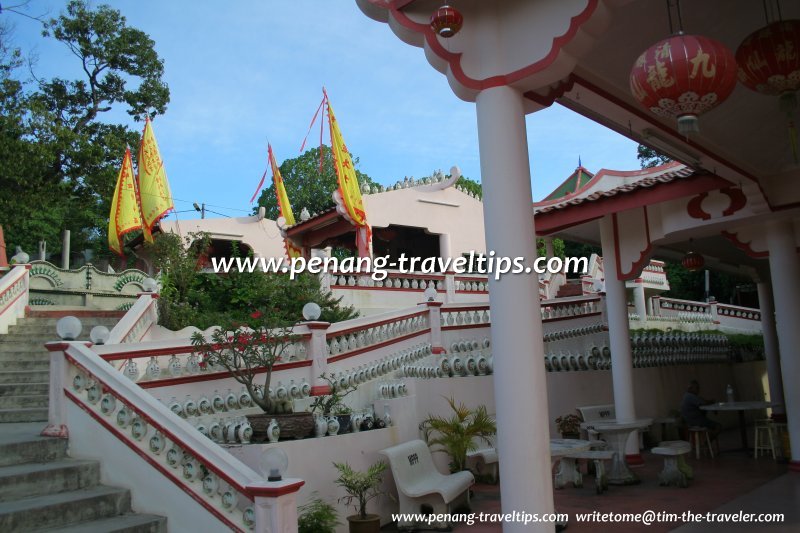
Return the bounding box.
[380,440,475,528]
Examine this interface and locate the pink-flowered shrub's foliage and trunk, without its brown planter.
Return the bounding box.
[192,320,298,413]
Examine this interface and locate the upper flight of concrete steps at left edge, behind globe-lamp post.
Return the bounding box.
[0,313,119,423]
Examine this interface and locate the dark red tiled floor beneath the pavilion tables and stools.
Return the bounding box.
[387,434,800,533]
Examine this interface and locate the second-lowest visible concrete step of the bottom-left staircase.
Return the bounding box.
[0,485,131,531]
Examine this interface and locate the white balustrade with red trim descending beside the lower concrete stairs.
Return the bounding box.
[44,343,303,531]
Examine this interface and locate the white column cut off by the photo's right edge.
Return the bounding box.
[767,221,800,471]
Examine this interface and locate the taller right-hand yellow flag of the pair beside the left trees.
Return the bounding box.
[138,117,175,242]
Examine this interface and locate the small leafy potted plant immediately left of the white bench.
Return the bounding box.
[333,461,388,533]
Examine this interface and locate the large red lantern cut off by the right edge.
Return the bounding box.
[736,20,800,112]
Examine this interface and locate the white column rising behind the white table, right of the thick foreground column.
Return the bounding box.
[600,215,639,458]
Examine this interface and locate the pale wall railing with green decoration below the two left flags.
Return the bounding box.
[30,261,148,311]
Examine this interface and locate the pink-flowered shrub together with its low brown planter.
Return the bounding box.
[192,318,314,440]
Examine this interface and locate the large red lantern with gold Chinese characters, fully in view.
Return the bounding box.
[630,35,736,135]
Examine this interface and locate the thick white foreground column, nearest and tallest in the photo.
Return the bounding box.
[476,87,553,533]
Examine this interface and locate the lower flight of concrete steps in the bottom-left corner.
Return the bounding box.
[0,423,167,533]
